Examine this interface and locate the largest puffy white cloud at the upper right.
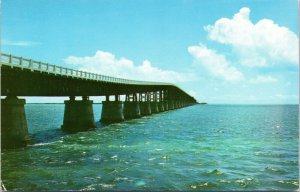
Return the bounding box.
[204,7,299,67]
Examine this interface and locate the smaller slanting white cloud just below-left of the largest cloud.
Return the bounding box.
[188,44,244,81]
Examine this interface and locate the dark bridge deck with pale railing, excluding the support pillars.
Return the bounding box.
[1,53,196,102]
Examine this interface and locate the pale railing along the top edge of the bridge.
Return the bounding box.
[0,53,173,85]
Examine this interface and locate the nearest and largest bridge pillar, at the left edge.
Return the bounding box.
[1,96,29,149]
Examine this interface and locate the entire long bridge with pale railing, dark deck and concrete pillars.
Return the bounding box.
[1,53,196,148]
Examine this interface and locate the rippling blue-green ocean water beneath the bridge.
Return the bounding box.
[1,104,299,191]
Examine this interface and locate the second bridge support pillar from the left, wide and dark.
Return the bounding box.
[61,97,96,132]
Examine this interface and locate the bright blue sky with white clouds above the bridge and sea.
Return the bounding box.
[1,0,299,104]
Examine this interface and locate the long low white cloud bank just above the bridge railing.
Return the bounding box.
[65,51,196,83]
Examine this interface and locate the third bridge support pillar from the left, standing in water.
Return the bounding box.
[100,101,124,123]
